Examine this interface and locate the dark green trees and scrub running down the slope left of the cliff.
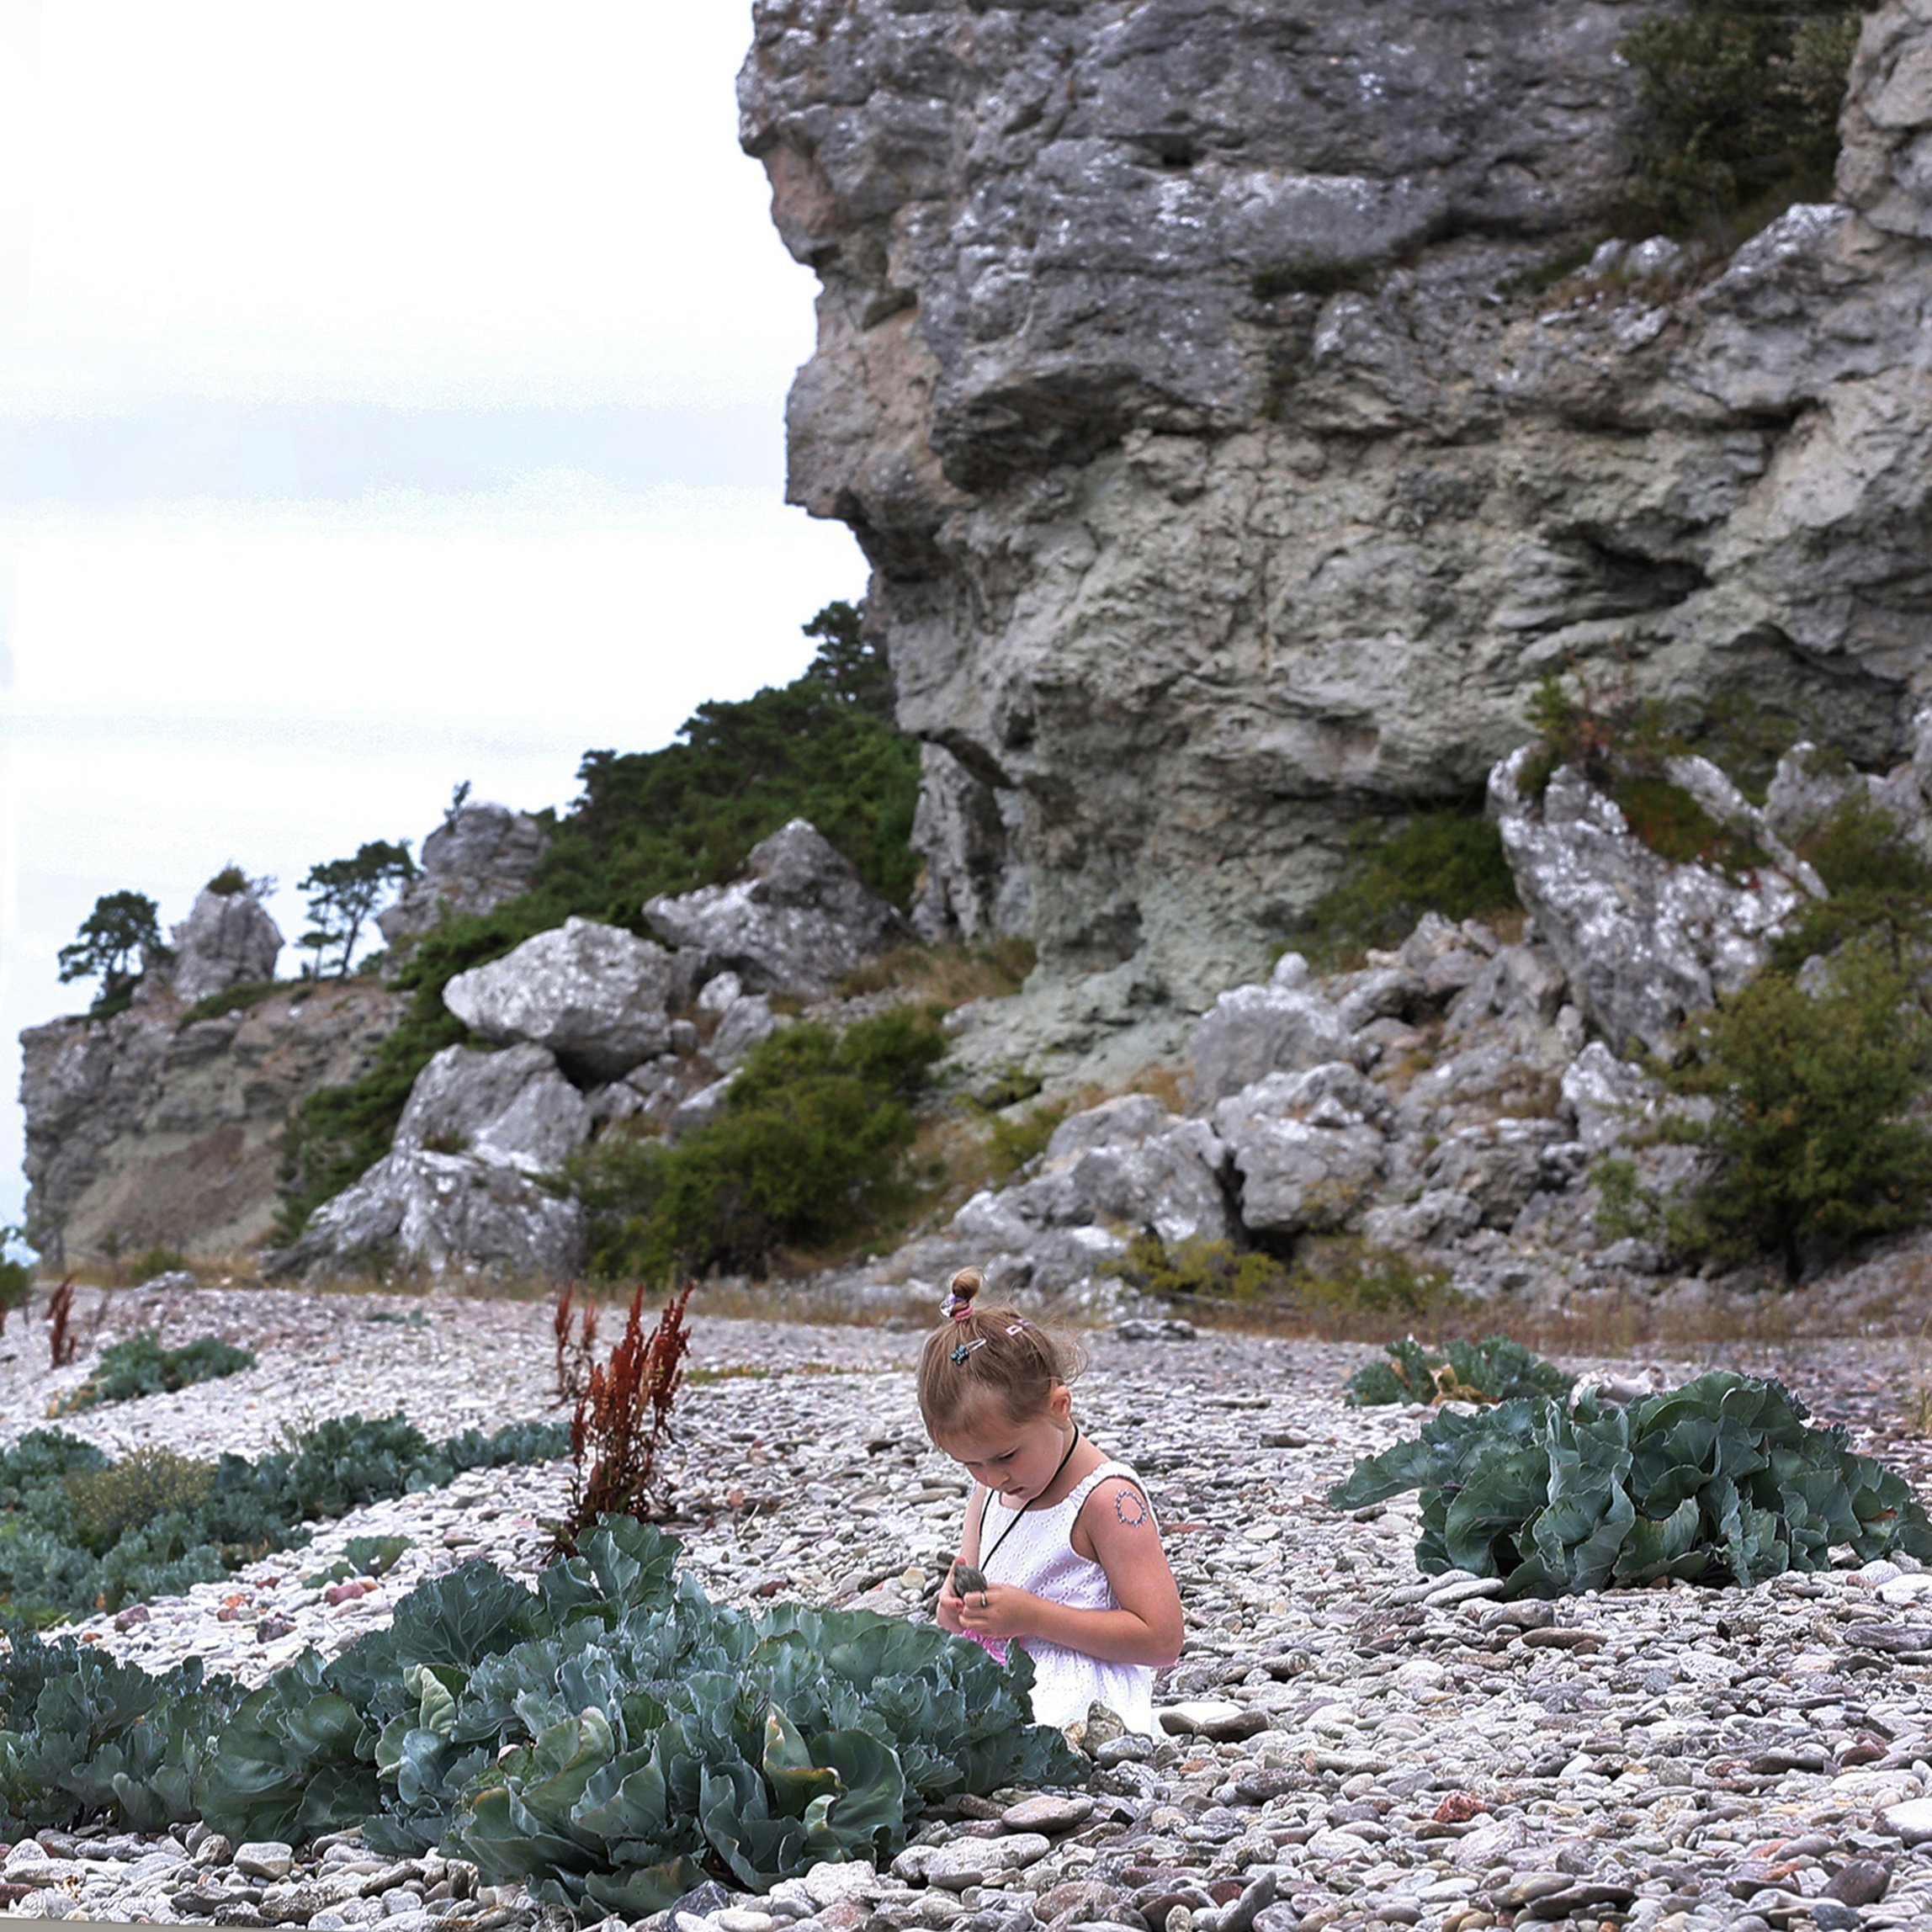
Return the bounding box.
[276,605,920,1242]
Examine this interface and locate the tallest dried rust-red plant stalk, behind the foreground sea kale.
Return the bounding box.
[556,1281,696,1549]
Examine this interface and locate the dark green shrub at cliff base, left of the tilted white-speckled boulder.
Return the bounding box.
[1298,809,1521,962]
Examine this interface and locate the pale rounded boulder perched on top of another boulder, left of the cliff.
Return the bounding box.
[443,920,671,1080]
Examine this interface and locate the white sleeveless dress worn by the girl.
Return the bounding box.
[979,1462,1157,1737]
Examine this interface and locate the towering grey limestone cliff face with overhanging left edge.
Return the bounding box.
[740,0,1932,1005]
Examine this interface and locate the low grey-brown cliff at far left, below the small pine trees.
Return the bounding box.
[19,981,404,1266]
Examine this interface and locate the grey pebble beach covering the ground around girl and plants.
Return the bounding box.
[0,1291,1932,1932]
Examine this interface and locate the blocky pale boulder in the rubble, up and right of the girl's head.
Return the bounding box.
[1213,1061,1391,1234]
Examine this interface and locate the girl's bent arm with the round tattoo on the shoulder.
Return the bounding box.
[948,1476,1181,1665]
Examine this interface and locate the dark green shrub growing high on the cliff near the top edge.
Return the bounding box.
[1619,0,1859,249]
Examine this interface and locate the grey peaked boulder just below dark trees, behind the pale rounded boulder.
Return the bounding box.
[644,820,912,997]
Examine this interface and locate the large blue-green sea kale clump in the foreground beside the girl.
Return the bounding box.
[0,1516,1084,1919]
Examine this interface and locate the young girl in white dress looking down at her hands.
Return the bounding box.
[920,1267,1181,1733]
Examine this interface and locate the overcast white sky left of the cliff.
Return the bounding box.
[0,0,863,1221]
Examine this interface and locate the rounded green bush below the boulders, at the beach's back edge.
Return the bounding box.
[566,1006,945,1279]
